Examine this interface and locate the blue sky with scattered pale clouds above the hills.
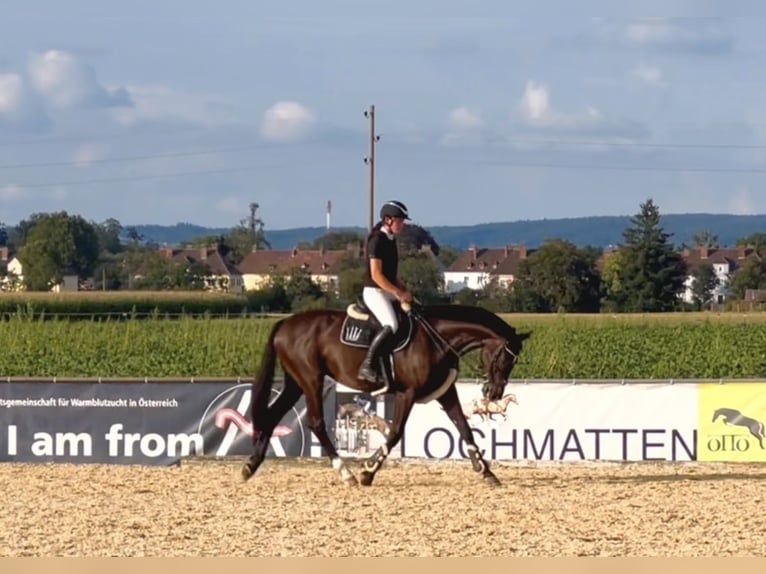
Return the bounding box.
[0,0,766,230]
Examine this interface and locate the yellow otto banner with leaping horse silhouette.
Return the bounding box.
[697,382,766,462]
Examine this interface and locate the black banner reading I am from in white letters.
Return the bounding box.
[0,381,335,465]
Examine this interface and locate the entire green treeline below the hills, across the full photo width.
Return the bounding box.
[0,199,766,313]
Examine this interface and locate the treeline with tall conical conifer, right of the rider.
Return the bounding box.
[453,199,766,313]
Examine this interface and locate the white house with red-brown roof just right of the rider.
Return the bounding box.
[444,245,534,293]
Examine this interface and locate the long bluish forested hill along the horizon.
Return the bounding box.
[130,213,766,249]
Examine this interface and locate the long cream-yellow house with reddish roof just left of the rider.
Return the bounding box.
[237,244,362,291]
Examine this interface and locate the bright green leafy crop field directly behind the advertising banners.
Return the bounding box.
[0,313,766,379]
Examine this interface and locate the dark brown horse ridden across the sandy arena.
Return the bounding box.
[241,300,531,486]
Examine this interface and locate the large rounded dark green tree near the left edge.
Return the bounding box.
[19,211,99,291]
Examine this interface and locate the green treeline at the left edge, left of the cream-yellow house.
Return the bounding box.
[0,204,269,291]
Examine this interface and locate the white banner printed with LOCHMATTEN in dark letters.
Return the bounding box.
[401,382,697,461]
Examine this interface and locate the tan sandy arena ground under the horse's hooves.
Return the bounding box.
[0,459,766,557]
